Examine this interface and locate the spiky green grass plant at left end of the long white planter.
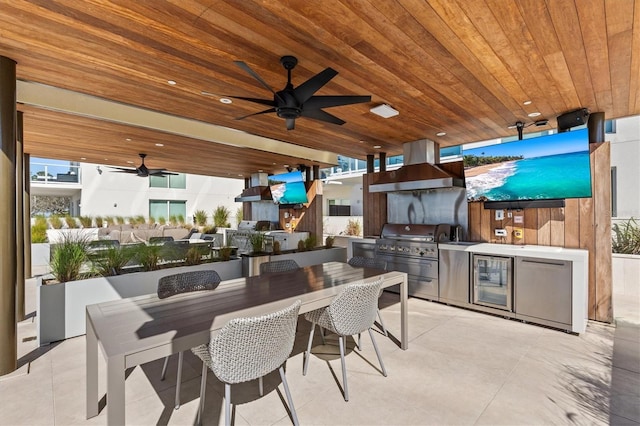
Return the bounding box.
[49,234,89,283]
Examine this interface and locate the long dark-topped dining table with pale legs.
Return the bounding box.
[86,262,408,425]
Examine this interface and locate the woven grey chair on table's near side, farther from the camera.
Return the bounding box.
[302,278,387,401]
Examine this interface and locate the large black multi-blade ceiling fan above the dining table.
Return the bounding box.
[229,56,371,130]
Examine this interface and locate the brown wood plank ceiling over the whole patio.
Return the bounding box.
[0,0,640,176]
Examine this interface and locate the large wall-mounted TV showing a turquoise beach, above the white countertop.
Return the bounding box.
[463,128,591,201]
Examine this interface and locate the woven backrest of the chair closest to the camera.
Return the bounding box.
[209,300,301,383]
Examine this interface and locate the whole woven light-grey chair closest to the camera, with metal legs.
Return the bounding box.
[191,300,301,426]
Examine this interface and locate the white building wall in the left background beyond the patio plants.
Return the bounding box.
[81,163,244,227]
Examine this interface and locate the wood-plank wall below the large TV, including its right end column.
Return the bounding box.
[468,143,613,322]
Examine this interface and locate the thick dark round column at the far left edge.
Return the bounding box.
[0,56,18,376]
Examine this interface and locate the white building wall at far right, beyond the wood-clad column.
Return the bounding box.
[605,116,640,219]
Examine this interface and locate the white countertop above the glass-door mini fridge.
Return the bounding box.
[438,242,589,261]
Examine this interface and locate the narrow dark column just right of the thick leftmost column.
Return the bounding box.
[16,112,26,322]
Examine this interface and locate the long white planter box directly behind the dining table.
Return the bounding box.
[36,259,242,345]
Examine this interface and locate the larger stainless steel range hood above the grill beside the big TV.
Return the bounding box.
[369,139,464,192]
